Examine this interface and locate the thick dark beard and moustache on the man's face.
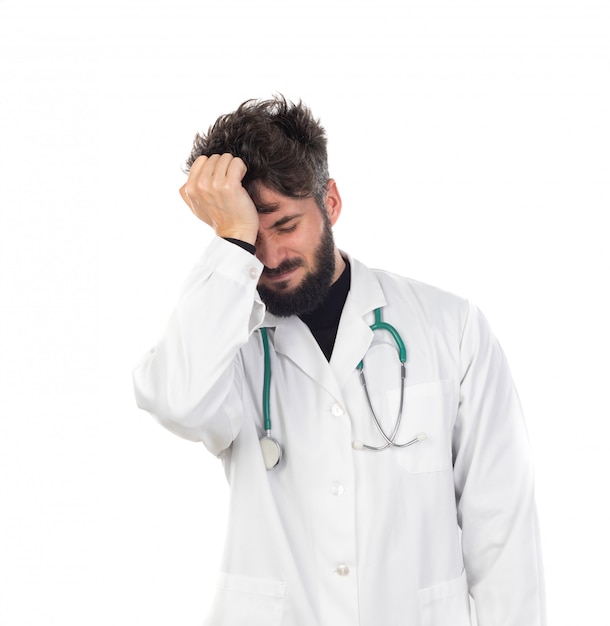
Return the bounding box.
[258,214,335,317]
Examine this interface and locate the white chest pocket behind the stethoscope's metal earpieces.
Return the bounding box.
[388,380,456,474]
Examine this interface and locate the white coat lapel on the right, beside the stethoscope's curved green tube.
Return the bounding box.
[330,258,386,388]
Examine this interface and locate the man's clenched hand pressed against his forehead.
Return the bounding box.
[180,154,258,245]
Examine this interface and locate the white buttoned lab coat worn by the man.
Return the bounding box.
[134,239,545,626]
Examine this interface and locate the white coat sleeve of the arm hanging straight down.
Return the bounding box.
[453,306,546,626]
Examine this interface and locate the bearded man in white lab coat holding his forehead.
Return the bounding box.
[134,98,545,626]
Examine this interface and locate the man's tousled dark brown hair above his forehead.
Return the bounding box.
[186,95,329,209]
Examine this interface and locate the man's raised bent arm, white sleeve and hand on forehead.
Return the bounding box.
[133,155,264,453]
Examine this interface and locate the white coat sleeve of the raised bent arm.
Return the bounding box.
[133,238,265,454]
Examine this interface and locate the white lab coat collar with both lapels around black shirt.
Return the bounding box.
[262,253,386,397]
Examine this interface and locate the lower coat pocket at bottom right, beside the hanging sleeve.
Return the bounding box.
[419,571,471,626]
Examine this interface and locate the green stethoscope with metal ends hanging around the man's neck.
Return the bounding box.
[260,309,426,470]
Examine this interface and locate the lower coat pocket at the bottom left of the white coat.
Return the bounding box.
[205,574,286,626]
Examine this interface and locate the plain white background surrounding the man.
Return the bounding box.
[0,0,610,626]
